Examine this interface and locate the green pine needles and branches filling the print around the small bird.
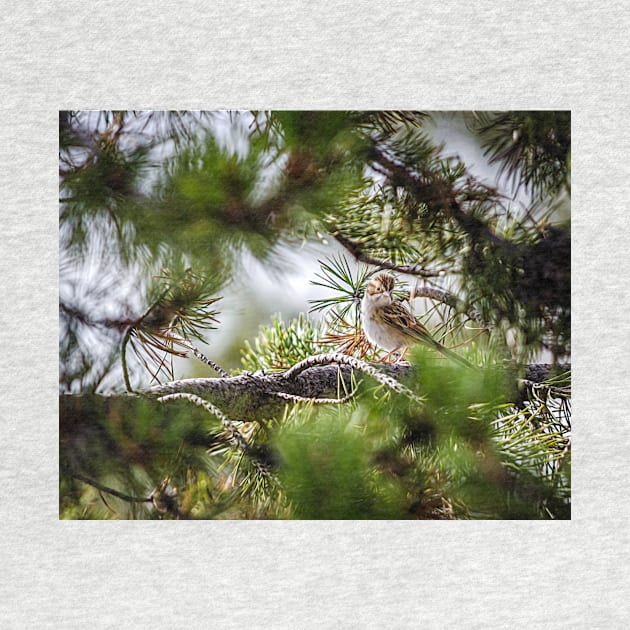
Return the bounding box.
[59,111,571,519]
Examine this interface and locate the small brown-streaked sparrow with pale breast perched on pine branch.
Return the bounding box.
[361,273,472,367]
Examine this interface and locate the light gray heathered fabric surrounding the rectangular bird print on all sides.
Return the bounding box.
[0,0,630,628]
